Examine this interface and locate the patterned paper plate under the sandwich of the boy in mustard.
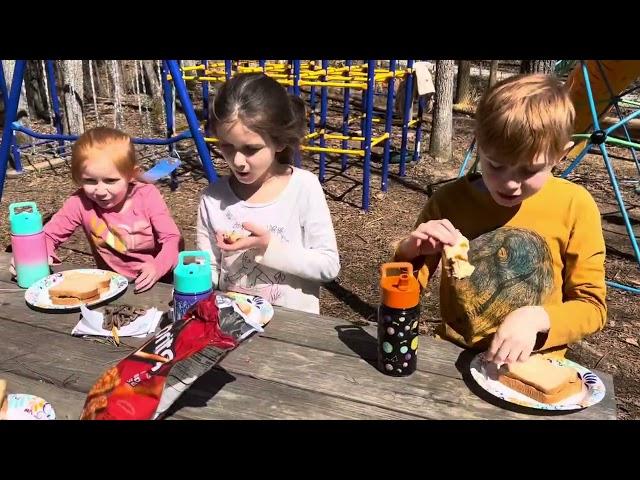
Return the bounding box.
[470,352,606,410]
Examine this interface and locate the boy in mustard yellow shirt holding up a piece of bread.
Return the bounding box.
[395,75,607,363]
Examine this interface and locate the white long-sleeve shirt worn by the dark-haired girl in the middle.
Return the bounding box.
[196,168,340,313]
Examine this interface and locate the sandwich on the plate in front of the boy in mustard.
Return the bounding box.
[498,355,582,404]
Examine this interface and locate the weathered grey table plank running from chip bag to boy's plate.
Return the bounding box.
[221,338,615,419]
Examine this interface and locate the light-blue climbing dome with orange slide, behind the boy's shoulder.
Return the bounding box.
[458,60,640,293]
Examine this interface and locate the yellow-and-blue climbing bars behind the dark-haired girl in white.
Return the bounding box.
[171,60,425,211]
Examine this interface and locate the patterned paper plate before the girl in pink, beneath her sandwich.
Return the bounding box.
[24,268,129,310]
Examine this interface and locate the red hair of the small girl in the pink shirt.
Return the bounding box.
[71,127,136,184]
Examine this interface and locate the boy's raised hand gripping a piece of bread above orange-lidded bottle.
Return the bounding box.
[399,218,460,259]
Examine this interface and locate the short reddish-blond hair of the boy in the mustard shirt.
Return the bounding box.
[475,74,575,165]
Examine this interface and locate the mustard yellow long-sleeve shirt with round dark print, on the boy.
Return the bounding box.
[396,176,607,354]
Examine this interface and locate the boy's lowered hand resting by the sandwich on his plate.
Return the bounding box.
[485,307,550,364]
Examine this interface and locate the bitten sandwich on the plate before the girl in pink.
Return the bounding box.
[49,271,111,305]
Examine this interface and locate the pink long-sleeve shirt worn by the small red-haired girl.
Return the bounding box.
[44,183,180,279]
